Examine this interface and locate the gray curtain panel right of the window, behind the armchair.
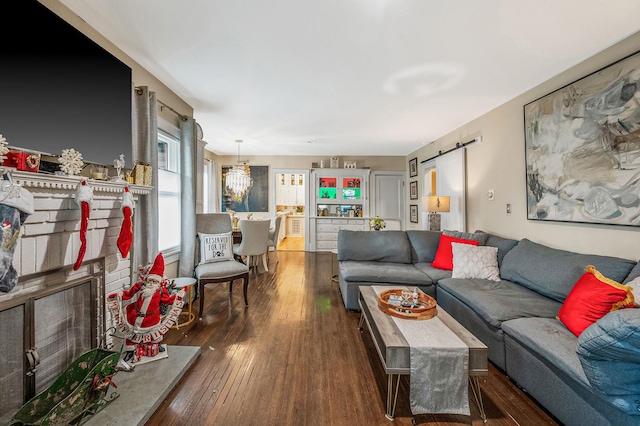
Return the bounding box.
[178,116,197,277]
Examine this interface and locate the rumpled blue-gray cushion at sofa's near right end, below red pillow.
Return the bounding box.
[578,309,640,416]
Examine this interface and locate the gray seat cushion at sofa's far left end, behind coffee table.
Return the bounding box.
[338,262,433,285]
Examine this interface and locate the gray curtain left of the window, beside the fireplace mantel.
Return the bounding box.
[131,86,158,274]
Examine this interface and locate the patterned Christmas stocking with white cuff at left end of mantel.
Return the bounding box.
[0,173,34,293]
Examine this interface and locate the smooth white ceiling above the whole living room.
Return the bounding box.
[60,0,640,156]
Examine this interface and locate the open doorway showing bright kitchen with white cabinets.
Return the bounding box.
[272,169,309,251]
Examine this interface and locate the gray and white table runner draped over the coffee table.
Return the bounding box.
[373,286,471,416]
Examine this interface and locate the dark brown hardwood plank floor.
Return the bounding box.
[147,251,557,426]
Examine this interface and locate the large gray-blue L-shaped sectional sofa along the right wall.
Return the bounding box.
[338,230,640,425]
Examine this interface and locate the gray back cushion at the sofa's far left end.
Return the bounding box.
[338,229,411,263]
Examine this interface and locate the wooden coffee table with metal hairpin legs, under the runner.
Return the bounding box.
[358,286,489,422]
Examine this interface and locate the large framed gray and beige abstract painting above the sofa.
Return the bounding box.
[524,53,640,226]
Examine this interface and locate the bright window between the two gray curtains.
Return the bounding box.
[158,129,181,253]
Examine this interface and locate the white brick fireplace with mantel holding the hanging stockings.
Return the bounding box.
[0,172,151,420]
